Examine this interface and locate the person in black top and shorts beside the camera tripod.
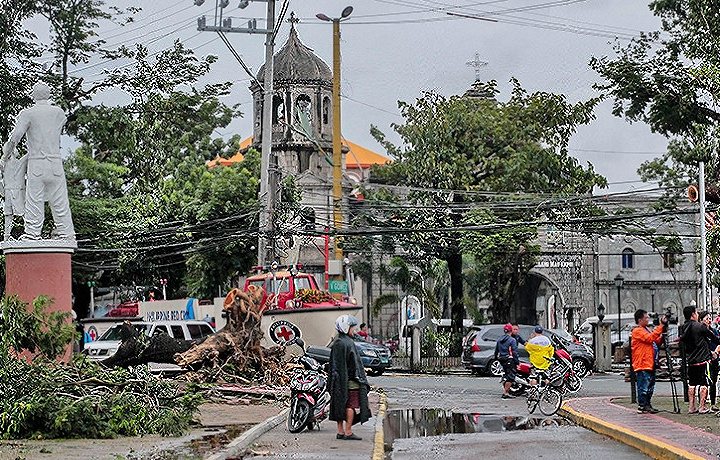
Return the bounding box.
[680,306,718,414]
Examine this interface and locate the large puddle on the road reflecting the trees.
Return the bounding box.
[383,409,572,452]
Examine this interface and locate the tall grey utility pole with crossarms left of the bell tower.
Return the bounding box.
[194,0,277,266]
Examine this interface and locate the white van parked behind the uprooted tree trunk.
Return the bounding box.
[83,320,215,360]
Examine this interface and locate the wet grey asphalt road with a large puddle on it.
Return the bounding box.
[371,374,656,460]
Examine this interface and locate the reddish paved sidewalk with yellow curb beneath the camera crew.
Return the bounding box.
[558,397,720,459]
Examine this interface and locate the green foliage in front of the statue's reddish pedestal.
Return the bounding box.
[0,295,75,360]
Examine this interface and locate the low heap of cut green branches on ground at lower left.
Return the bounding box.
[0,354,202,439]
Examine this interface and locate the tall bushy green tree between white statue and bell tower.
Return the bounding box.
[62,42,253,297]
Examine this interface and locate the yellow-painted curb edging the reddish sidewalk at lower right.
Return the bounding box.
[558,404,705,460]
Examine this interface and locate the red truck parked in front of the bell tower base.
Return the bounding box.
[243,267,357,310]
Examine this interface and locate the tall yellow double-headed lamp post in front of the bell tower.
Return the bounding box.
[315,6,353,260]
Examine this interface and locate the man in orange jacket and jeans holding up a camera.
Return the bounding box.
[630,308,668,414]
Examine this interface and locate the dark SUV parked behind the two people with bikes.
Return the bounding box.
[462,324,595,378]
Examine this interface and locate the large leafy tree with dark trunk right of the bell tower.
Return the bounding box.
[362,80,606,332]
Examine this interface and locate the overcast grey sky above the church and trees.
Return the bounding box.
[40,0,667,194]
